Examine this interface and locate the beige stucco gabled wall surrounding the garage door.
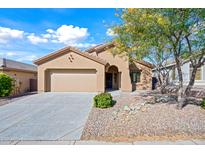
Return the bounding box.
[38,51,105,92]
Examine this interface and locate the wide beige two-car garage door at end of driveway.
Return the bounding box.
[49,69,97,92]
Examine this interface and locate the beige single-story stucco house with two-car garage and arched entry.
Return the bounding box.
[34,43,152,92]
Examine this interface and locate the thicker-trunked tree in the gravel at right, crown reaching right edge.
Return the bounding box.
[155,9,205,108]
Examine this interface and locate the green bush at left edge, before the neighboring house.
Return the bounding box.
[0,73,13,97]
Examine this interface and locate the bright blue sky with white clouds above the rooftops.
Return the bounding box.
[0,9,119,63]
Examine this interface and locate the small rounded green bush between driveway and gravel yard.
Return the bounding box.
[94,93,113,108]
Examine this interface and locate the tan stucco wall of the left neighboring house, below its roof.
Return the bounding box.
[2,70,37,94]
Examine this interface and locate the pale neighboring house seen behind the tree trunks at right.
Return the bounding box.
[153,60,205,87]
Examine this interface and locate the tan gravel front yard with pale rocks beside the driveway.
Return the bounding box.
[81,91,205,141]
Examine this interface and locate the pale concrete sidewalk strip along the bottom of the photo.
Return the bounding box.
[0,140,205,145]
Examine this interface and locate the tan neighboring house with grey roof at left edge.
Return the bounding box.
[0,58,37,95]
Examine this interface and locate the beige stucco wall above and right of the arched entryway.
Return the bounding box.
[95,49,132,91]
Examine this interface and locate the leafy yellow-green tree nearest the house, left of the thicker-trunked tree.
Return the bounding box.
[113,9,172,93]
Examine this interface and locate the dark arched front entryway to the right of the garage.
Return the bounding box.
[105,65,120,90]
